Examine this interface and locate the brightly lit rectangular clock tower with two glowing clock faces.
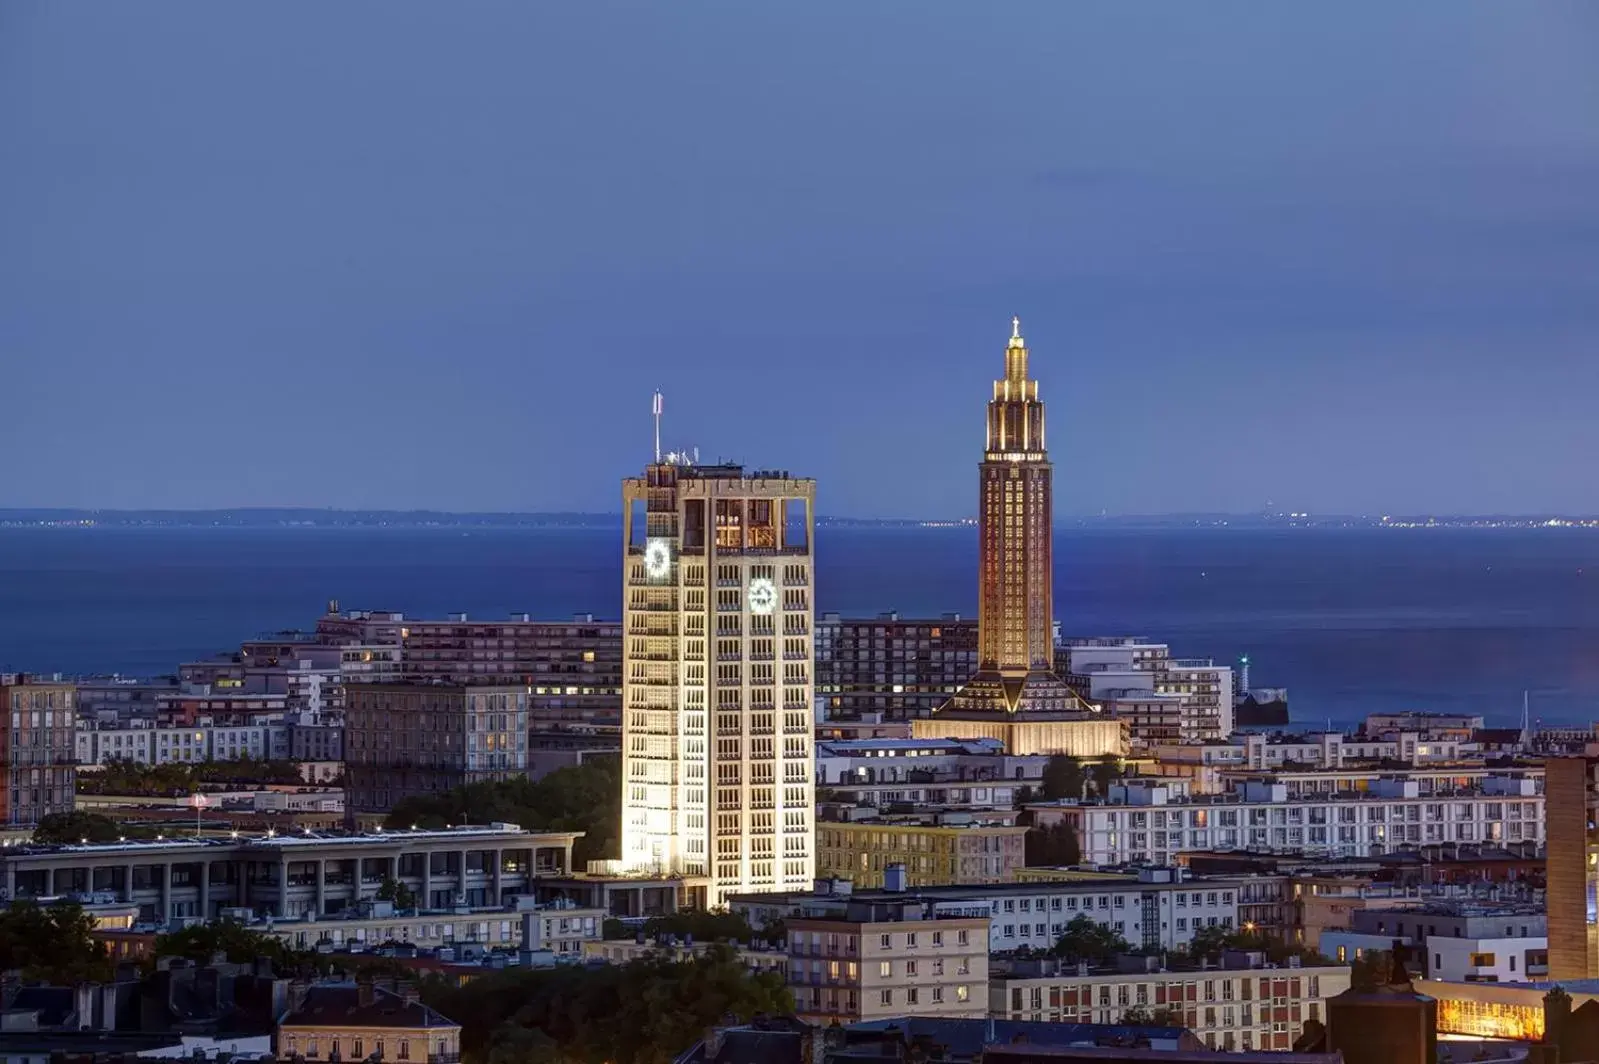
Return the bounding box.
[622,456,815,906]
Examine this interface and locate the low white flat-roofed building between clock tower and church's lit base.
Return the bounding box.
[815,739,1049,811]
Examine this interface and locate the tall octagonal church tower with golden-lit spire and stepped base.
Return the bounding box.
[913,318,1126,757]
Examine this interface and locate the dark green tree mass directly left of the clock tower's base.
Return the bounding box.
[385,758,622,867]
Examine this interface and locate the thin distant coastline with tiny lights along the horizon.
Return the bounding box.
[0,507,1599,530]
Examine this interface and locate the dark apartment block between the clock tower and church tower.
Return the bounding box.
[815,613,977,720]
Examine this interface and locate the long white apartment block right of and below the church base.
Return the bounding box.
[1028,771,1543,866]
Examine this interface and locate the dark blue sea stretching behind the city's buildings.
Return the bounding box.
[0,526,1599,726]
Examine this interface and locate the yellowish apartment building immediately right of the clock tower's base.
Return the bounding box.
[815,810,1028,890]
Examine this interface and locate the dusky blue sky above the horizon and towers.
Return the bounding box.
[0,0,1599,517]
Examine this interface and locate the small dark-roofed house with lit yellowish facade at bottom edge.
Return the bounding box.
[277,978,461,1064]
